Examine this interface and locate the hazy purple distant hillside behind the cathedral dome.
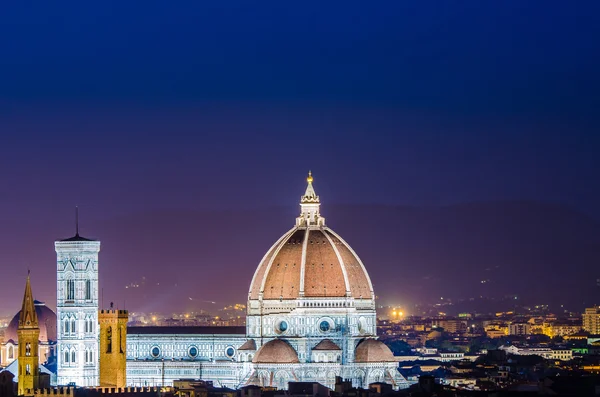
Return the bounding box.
[0,202,600,311]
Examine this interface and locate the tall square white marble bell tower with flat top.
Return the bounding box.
[54,212,100,386]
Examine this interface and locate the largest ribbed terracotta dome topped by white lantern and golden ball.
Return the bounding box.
[249,174,373,300]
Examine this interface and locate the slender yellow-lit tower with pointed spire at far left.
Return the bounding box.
[17,274,40,396]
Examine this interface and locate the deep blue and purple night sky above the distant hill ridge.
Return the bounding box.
[0,1,600,312]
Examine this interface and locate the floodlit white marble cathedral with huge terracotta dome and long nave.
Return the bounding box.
[127,174,408,389]
